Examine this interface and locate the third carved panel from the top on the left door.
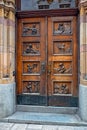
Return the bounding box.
[23,61,40,75]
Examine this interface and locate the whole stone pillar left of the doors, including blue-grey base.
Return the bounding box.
[0,0,15,117]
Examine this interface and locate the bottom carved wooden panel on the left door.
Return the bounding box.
[23,81,40,93]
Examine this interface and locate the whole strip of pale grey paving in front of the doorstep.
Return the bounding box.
[0,122,87,130]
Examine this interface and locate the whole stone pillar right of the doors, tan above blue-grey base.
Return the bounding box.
[79,0,87,121]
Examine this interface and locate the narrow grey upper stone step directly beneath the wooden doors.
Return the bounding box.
[17,105,78,114]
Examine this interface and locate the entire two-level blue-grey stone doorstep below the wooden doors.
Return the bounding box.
[0,106,87,126]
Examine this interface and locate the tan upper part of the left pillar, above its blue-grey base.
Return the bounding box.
[0,0,15,84]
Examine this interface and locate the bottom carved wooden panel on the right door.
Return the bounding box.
[53,81,72,94]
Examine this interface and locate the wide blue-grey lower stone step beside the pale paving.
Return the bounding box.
[2,111,87,126]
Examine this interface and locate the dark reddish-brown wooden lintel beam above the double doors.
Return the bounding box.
[16,8,79,18]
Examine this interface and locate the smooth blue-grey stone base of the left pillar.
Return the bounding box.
[0,83,16,118]
